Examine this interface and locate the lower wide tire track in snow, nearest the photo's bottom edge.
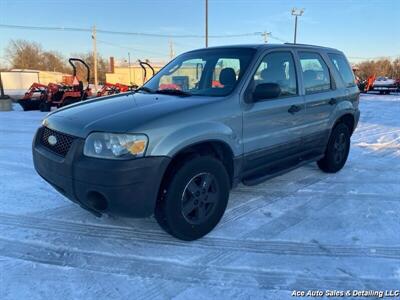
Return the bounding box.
[0,238,398,293]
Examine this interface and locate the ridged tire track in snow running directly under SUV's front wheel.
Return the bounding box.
[0,214,400,259]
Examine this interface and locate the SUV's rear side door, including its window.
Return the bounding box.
[298,51,343,154]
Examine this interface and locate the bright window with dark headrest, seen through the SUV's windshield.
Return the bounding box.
[212,58,240,88]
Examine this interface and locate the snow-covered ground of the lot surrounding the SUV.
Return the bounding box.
[0,94,400,299]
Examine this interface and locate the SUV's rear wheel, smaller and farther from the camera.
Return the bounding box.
[317,123,350,173]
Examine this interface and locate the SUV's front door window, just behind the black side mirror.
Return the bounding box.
[253,52,297,97]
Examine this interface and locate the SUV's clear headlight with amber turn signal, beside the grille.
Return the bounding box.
[83,132,148,159]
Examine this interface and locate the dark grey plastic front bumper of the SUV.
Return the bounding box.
[32,128,170,217]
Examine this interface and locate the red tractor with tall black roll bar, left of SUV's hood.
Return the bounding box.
[39,58,92,111]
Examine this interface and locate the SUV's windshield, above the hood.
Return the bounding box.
[144,48,256,96]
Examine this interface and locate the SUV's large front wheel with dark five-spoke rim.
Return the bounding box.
[155,156,230,241]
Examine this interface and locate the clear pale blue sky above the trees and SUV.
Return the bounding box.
[0,0,400,62]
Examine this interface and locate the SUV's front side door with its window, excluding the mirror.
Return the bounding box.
[243,50,305,171]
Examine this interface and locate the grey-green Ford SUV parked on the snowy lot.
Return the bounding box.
[33,44,360,240]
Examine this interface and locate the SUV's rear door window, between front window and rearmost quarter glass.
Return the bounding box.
[299,52,331,94]
